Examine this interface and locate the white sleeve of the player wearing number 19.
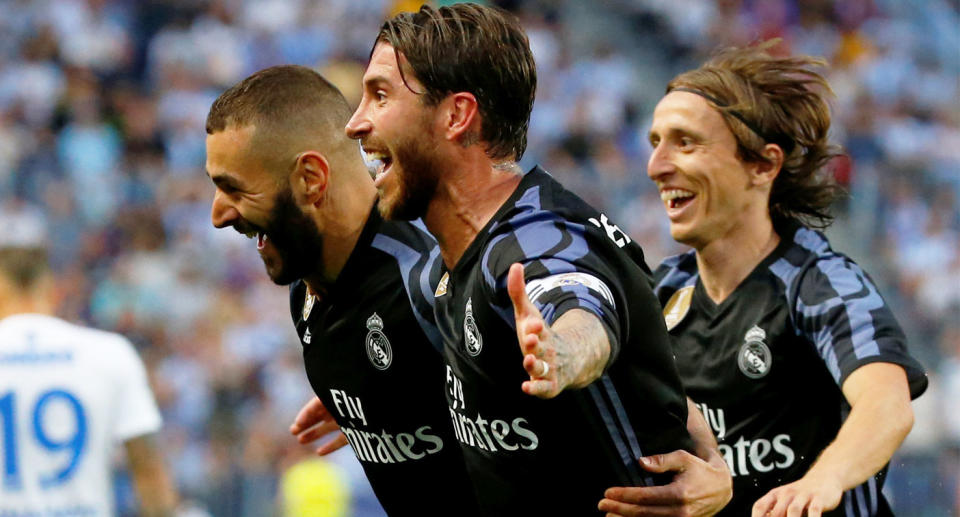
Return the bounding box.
[113,338,162,441]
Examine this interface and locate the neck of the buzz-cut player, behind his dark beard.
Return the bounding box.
[304,170,377,293]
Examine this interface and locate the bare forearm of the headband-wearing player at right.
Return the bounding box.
[804,374,913,491]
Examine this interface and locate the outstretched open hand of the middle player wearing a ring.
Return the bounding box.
[507,263,565,399]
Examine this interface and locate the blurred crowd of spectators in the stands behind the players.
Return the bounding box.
[0,0,960,517]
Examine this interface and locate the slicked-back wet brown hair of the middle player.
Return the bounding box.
[371,3,537,160]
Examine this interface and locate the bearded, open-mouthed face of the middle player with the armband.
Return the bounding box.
[346,42,440,220]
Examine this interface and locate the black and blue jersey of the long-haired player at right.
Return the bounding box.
[655,219,927,517]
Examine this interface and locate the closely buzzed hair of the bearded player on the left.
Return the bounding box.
[206,65,355,164]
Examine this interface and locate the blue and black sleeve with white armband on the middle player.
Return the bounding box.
[480,186,626,358]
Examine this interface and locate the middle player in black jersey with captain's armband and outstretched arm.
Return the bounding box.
[347,4,729,516]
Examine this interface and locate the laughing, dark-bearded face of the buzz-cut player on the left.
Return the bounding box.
[207,126,322,285]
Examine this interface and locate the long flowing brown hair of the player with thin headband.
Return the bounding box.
[667,40,843,228]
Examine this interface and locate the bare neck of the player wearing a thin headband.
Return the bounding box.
[697,217,780,303]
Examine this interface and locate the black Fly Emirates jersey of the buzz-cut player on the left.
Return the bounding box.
[290,209,476,516]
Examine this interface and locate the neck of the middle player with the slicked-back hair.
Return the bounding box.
[423,160,523,269]
